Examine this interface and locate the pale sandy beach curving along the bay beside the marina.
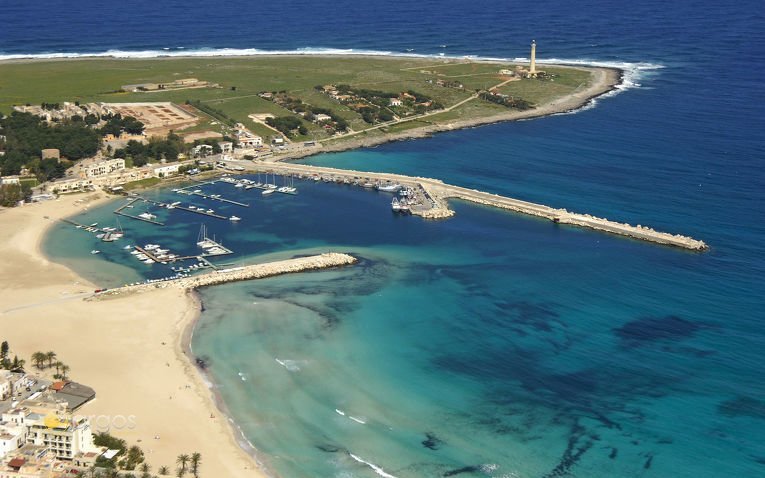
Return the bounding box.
[0,193,267,477]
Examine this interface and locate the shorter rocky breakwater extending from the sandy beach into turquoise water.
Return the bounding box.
[91,252,357,299]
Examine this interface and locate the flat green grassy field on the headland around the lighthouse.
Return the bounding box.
[0,56,591,141]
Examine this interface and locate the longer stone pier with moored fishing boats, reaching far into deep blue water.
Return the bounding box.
[245,163,709,251]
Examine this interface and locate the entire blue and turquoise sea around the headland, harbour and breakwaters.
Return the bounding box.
[16,1,765,477]
